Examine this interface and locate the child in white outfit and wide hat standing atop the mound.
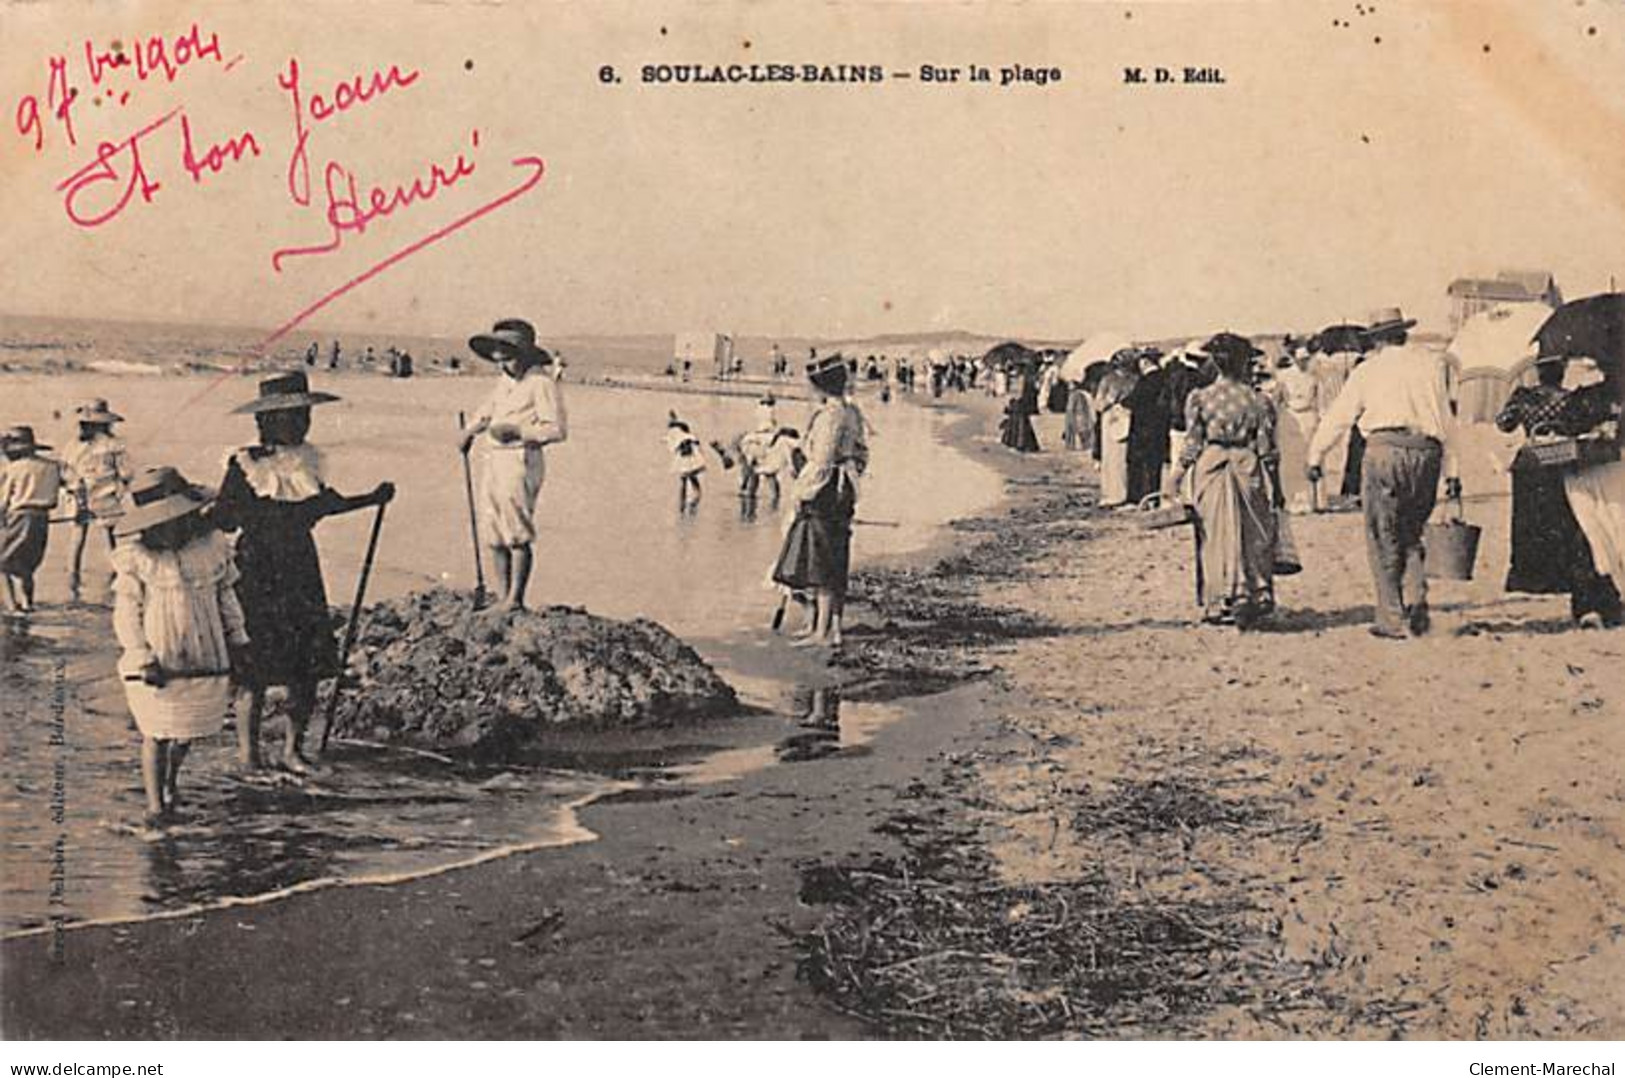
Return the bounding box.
[458,319,569,610]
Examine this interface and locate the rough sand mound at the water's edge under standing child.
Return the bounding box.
[335,589,738,756]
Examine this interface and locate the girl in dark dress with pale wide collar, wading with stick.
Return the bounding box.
[211,371,395,772]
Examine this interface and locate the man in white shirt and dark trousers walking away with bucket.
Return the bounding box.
[1308,307,1461,639]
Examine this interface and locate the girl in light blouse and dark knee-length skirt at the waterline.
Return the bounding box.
[774,354,869,645]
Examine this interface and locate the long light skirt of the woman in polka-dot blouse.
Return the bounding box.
[1194,446,1276,610]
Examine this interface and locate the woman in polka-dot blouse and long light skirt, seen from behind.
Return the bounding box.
[1165,333,1279,629]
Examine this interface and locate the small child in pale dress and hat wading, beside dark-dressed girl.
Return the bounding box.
[112,468,249,824]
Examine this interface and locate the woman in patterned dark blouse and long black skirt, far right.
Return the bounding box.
[1495,356,1622,624]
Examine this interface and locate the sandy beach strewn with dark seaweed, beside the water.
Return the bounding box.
[0,391,1625,1039]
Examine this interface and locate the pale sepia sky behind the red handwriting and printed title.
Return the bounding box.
[0,0,1625,338]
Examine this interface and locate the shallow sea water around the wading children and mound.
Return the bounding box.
[0,364,1001,930]
